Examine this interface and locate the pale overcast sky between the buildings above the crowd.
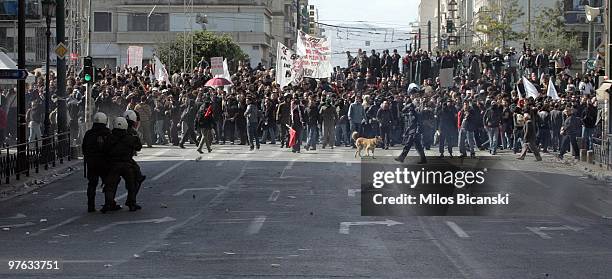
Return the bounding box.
[309,0,418,66]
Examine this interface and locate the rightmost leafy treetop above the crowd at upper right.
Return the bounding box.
[532,1,580,53]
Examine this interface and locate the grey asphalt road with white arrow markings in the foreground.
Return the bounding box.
[0,145,612,278]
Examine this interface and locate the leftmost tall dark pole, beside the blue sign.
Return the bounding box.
[17,0,26,172]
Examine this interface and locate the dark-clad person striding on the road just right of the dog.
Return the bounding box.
[395,103,427,164]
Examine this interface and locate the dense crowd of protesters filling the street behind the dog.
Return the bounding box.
[0,42,601,163]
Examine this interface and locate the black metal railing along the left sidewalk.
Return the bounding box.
[0,132,71,184]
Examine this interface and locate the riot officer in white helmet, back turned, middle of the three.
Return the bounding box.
[100,117,142,213]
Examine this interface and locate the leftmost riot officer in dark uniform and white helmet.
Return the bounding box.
[82,112,111,212]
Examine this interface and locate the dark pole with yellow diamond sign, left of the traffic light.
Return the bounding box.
[55,0,68,140]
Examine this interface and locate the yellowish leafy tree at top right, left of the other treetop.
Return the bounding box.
[476,0,525,48]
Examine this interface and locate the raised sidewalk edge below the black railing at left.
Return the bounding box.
[0,159,83,202]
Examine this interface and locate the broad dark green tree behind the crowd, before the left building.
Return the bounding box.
[155,31,248,73]
